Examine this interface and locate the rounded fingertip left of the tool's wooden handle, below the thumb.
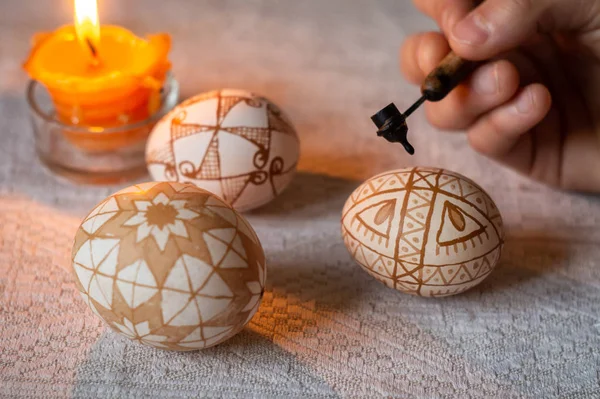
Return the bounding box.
[400,32,450,84]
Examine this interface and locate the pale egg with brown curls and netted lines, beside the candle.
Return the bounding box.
[146,90,299,211]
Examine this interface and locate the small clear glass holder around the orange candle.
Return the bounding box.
[27,73,179,184]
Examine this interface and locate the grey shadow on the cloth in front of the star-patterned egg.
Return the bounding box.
[72,328,338,398]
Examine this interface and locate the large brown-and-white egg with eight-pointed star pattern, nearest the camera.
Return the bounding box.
[72,182,265,351]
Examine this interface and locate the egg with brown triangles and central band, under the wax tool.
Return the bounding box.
[342,167,504,297]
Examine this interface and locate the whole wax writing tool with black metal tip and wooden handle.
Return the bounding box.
[371,52,479,155]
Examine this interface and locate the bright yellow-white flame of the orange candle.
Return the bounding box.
[75,0,100,64]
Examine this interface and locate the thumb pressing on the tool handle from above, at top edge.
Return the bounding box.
[449,0,600,60]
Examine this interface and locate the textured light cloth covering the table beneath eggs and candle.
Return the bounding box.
[0,0,600,398]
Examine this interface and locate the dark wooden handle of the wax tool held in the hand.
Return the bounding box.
[421,51,479,101]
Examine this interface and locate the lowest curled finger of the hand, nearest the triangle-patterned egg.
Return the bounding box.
[468,83,551,160]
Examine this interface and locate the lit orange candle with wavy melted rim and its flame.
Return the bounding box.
[24,0,171,150]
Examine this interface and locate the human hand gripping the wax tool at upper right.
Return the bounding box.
[401,0,600,192]
